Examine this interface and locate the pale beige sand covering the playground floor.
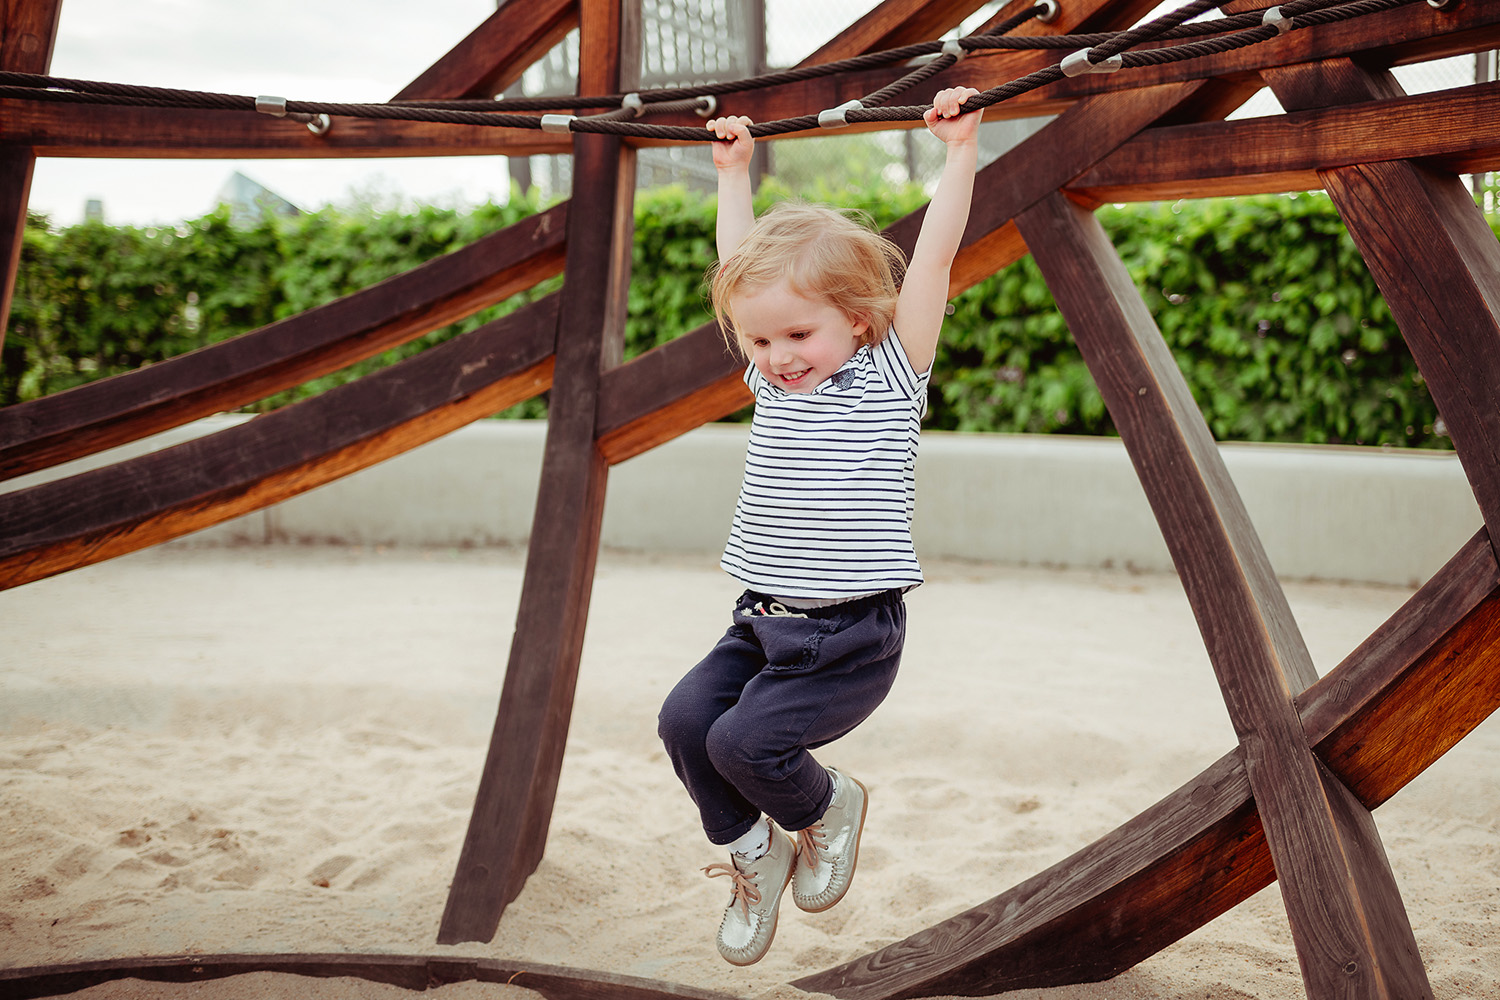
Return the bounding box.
[0,546,1500,1000]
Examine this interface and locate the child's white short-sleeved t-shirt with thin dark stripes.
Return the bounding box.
[719,330,927,600]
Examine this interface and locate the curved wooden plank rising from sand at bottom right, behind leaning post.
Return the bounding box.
[792,531,1500,1000]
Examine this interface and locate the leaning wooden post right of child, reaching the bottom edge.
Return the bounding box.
[1017,193,1433,1000]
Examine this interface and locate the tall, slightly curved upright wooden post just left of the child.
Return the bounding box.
[438,0,639,945]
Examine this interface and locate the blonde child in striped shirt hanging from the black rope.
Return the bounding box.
[659,87,980,966]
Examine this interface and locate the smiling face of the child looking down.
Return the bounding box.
[731,280,870,393]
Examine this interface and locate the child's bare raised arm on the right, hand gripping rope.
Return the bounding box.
[894,87,981,372]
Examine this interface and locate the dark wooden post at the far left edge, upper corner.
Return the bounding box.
[0,0,63,346]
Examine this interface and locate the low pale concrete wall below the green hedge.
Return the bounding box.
[0,417,1482,586]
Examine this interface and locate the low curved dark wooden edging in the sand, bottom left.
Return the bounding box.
[0,954,729,1000]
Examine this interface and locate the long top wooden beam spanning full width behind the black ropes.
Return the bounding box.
[0,3,1500,157]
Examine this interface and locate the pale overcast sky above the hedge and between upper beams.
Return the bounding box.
[30,0,873,225]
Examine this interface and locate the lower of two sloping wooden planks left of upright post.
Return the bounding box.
[0,295,558,589]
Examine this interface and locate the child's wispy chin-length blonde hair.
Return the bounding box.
[708,201,906,357]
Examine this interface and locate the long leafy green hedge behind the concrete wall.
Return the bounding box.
[0,184,1476,448]
